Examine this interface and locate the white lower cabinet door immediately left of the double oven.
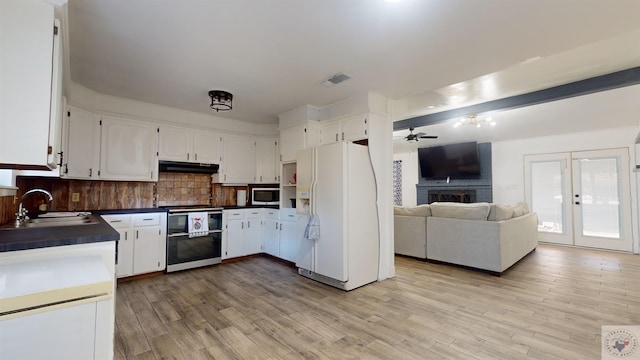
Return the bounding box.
[133,226,166,274]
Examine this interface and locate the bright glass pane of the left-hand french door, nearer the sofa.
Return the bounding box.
[531,160,565,234]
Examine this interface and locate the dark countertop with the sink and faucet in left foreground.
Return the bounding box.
[0,213,120,252]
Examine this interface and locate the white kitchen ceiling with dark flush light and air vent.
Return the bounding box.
[68,0,640,129]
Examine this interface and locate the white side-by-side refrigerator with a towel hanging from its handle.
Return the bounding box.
[296,142,380,290]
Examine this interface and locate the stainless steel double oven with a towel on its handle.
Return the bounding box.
[167,207,222,272]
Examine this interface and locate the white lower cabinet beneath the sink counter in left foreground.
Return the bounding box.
[0,241,116,360]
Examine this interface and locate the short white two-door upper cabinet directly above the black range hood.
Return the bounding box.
[158,126,222,164]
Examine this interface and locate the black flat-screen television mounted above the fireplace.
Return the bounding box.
[418,142,480,180]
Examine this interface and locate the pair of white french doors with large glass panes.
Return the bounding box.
[524,149,633,252]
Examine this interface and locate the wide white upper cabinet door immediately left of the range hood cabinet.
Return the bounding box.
[100,117,158,181]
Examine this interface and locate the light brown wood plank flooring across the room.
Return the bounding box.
[115,245,640,360]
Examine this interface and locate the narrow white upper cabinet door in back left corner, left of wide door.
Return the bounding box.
[60,107,100,179]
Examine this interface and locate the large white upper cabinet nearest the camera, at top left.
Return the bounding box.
[0,0,62,170]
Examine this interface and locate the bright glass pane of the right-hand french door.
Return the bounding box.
[580,158,620,238]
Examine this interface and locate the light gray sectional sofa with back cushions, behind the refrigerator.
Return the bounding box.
[394,202,538,274]
